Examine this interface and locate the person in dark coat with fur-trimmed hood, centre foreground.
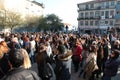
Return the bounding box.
[55,39,72,80]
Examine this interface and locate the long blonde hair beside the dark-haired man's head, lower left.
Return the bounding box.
[20,49,31,69]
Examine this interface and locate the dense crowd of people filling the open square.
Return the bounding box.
[0,27,120,80]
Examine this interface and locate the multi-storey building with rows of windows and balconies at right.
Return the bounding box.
[77,0,117,33]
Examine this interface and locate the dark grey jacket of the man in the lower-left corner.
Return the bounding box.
[2,67,41,80]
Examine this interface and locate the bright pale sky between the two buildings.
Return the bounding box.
[36,0,91,27]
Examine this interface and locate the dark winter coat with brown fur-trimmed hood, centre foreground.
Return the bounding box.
[55,50,72,80]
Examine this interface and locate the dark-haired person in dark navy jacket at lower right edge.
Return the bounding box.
[103,49,120,80]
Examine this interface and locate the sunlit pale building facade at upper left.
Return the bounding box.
[0,0,44,18]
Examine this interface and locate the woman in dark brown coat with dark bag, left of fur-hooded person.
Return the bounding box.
[36,44,53,80]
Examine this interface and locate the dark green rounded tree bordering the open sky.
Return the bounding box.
[38,14,63,31]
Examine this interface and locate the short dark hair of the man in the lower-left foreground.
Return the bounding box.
[8,49,24,68]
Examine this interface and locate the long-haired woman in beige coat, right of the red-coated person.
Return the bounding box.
[85,45,98,80]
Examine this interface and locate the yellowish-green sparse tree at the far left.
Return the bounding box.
[0,10,22,32]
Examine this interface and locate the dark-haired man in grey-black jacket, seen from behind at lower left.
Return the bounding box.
[2,49,41,80]
